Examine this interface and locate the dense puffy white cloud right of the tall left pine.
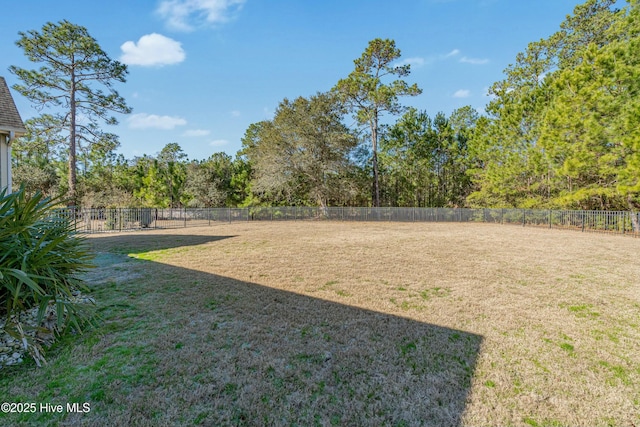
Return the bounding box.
[120,33,186,67]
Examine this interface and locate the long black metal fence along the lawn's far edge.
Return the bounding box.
[56,207,640,237]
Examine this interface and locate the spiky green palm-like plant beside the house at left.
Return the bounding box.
[0,189,93,361]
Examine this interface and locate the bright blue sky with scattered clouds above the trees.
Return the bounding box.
[0,0,582,159]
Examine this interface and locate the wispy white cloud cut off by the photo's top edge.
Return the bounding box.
[156,0,245,31]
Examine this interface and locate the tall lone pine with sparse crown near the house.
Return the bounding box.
[9,20,131,203]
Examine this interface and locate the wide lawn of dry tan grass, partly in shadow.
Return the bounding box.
[0,222,640,426]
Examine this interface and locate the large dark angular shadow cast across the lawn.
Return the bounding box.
[1,235,482,426]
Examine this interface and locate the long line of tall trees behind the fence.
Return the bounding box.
[11,0,640,214]
